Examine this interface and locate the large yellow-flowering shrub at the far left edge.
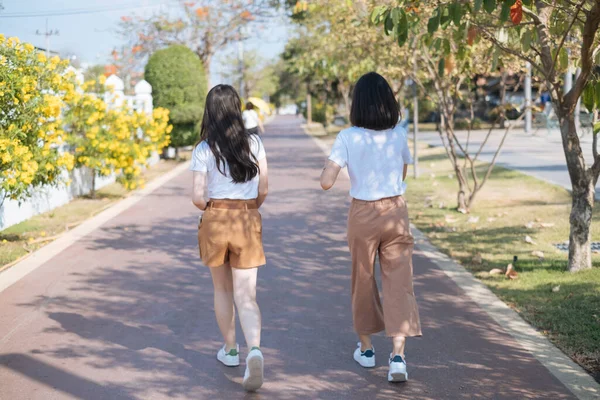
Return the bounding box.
[0,34,75,204]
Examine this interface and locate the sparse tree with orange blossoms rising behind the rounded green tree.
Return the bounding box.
[121,0,278,82]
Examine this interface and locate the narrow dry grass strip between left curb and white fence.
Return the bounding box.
[0,153,189,271]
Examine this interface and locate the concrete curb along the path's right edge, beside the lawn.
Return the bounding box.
[303,129,600,400]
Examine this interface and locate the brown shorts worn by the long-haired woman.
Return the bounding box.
[198,200,266,268]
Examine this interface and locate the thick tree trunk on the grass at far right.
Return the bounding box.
[559,109,595,272]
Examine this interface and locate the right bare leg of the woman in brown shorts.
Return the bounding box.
[232,268,261,349]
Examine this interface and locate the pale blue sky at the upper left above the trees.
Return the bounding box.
[0,0,288,83]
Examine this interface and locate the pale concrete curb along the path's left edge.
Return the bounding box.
[0,162,189,293]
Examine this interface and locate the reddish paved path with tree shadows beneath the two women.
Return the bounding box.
[0,118,574,400]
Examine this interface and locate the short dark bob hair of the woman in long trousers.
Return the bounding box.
[350,72,400,131]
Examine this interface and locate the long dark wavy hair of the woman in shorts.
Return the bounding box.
[200,85,258,183]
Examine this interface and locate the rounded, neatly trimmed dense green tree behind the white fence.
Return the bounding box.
[145,45,208,148]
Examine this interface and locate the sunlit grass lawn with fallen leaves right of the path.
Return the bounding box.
[406,143,600,381]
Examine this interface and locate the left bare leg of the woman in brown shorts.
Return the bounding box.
[210,264,236,351]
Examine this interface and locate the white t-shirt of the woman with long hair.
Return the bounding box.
[190,135,266,200]
